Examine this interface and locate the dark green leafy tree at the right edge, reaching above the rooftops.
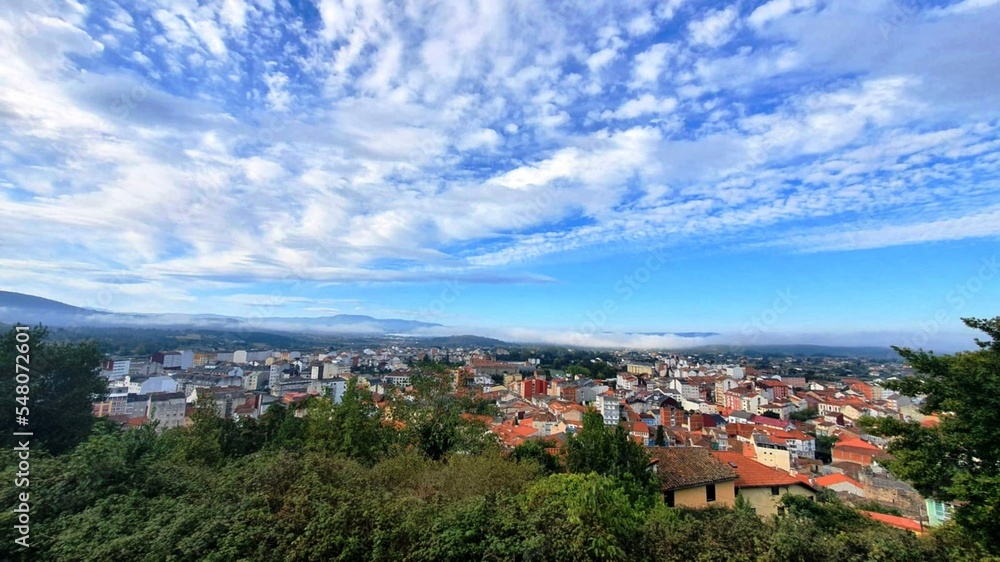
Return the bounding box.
[863,316,1000,555]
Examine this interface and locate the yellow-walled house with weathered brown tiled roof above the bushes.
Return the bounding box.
[650,447,739,507]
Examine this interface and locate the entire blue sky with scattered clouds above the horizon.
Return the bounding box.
[0,0,1000,350]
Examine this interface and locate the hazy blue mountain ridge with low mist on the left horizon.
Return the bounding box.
[0,291,441,335]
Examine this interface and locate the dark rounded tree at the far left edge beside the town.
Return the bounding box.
[0,326,108,454]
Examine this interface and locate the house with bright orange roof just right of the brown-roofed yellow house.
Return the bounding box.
[712,451,816,515]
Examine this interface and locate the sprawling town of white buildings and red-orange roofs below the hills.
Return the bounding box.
[93,345,936,534]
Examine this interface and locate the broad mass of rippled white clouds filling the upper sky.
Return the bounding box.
[0,0,1000,320]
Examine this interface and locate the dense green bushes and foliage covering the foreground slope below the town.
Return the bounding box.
[0,324,986,562]
